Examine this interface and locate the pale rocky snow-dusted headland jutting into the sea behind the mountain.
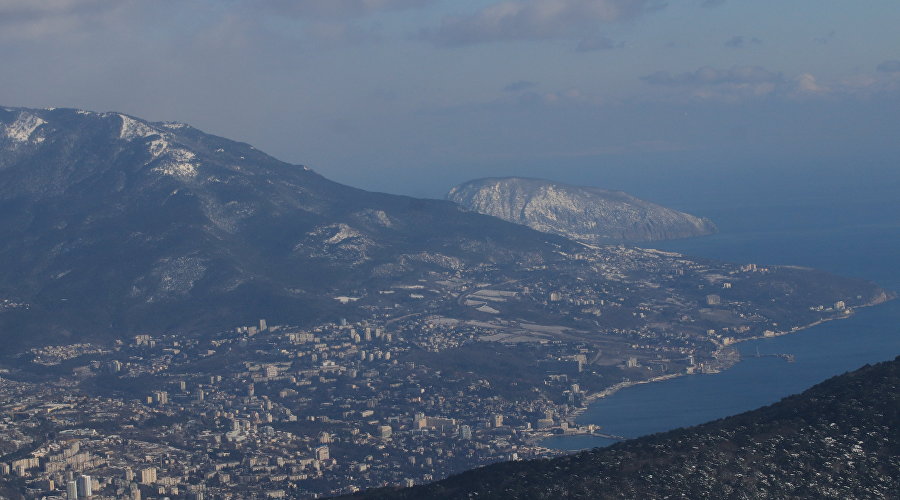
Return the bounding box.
[447,177,716,244]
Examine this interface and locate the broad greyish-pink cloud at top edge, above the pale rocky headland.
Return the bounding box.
[421,0,665,46]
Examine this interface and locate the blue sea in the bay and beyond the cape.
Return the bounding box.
[543,179,900,450]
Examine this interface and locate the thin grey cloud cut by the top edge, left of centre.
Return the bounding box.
[256,0,435,18]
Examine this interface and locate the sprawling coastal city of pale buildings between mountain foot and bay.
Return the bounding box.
[0,247,884,499]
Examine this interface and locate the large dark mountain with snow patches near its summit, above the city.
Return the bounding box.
[0,108,574,348]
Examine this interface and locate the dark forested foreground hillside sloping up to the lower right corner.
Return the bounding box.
[342,357,900,500]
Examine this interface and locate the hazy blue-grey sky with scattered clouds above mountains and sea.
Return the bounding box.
[0,0,900,205]
